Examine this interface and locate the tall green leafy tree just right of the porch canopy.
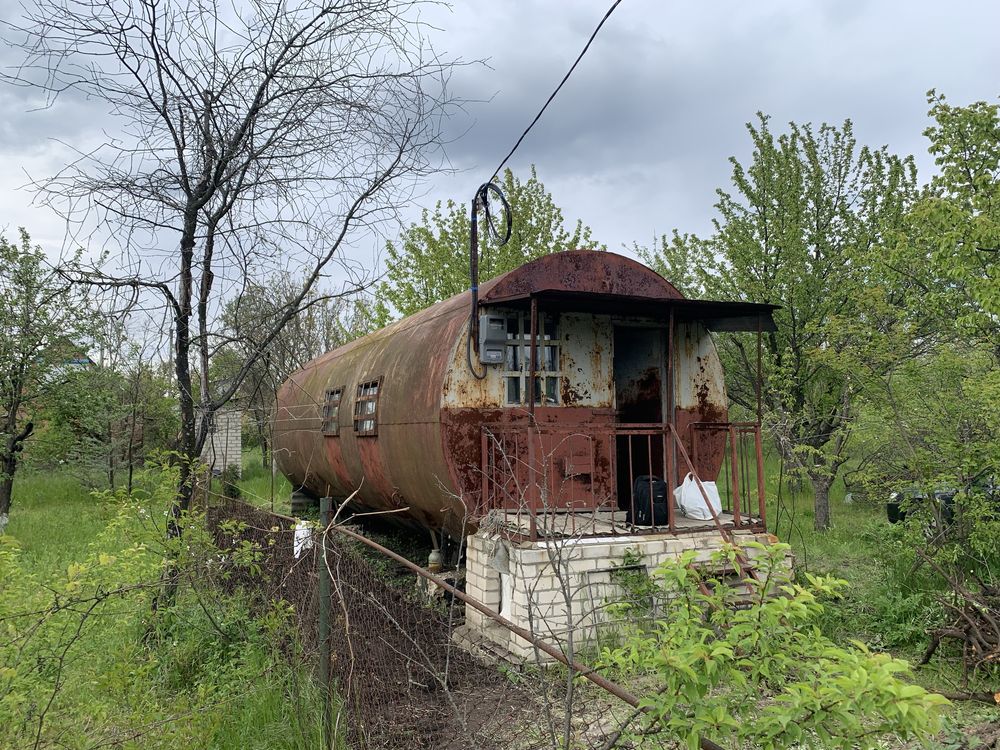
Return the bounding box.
[641,115,916,529]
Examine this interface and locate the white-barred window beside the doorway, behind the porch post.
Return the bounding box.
[503,313,562,406]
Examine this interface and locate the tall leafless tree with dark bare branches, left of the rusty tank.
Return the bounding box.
[5,0,454,528]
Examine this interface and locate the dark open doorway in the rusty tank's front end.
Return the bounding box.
[612,326,666,510]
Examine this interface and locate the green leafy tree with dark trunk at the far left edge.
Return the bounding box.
[0,229,92,533]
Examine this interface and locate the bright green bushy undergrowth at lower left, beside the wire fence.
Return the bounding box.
[0,468,321,750]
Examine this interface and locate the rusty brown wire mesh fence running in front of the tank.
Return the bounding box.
[207,496,672,750]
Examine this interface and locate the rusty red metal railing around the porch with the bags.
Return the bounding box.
[476,422,765,539]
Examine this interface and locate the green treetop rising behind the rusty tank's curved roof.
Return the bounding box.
[374,167,595,326]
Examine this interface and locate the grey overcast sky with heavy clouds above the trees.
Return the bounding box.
[0,0,1000,264]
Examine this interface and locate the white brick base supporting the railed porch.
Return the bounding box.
[465,531,767,658]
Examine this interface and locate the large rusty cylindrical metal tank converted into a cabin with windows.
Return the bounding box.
[274,250,760,532]
